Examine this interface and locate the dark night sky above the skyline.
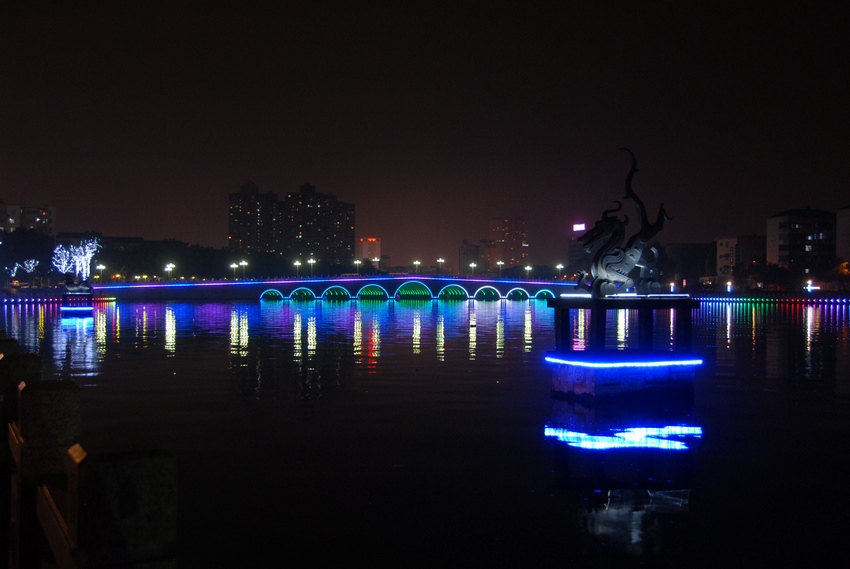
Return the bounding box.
[0,1,850,265]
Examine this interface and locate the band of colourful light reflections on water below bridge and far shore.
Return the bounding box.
[3,301,850,386]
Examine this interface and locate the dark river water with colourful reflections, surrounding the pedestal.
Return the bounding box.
[2,300,850,567]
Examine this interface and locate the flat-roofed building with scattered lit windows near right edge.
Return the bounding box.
[766,208,836,274]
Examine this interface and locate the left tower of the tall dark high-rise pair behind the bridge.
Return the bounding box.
[228,181,281,255]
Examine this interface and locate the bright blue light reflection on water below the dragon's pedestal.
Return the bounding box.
[543,425,702,450]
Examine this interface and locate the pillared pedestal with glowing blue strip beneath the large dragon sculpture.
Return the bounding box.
[546,295,702,398]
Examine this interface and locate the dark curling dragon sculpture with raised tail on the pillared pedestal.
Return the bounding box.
[579,148,671,297]
